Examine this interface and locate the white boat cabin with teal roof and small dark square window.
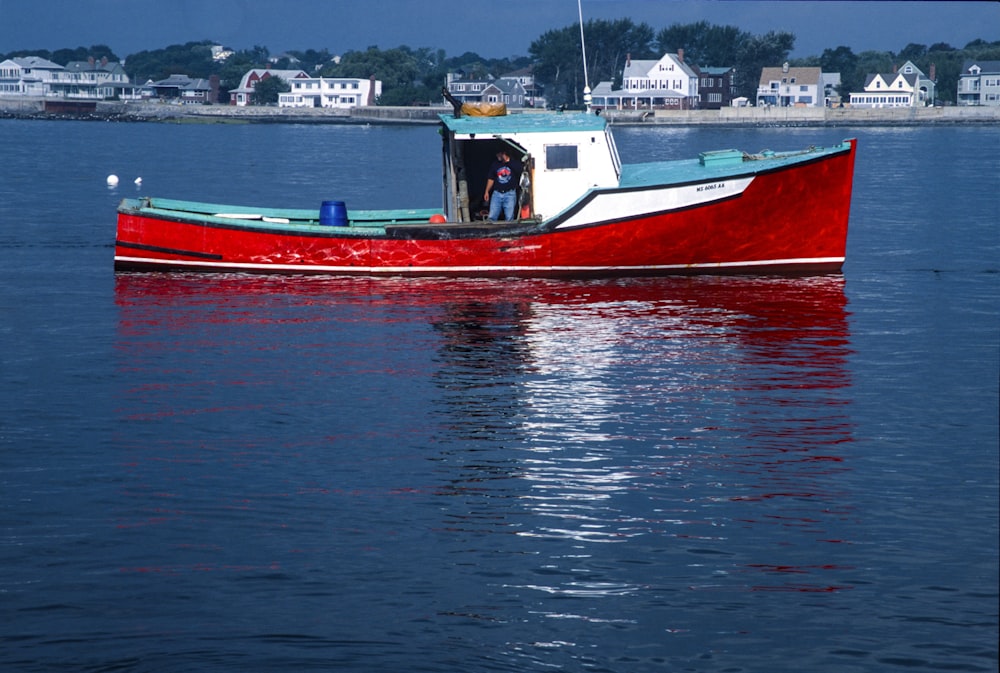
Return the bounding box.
[441,112,621,222]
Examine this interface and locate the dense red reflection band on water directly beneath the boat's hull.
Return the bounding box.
[115,273,847,324]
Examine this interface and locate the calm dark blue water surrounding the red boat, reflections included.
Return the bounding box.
[0,121,1000,673]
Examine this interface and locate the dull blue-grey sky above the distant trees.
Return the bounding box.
[0,0,1000,58]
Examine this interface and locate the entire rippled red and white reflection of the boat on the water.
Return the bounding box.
[115,273,852,600]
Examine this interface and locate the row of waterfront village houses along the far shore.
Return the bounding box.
[0,46,1000,122]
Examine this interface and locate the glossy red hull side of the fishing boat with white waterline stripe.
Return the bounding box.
[115,141,855,276]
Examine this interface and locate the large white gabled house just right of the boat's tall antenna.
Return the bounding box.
[593,49,698,110]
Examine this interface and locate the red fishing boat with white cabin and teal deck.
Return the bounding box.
[115,106,856,276]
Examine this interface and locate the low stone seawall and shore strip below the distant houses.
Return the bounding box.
[0,97,1000,127]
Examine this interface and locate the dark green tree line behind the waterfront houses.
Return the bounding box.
[0,19,1000,106]
